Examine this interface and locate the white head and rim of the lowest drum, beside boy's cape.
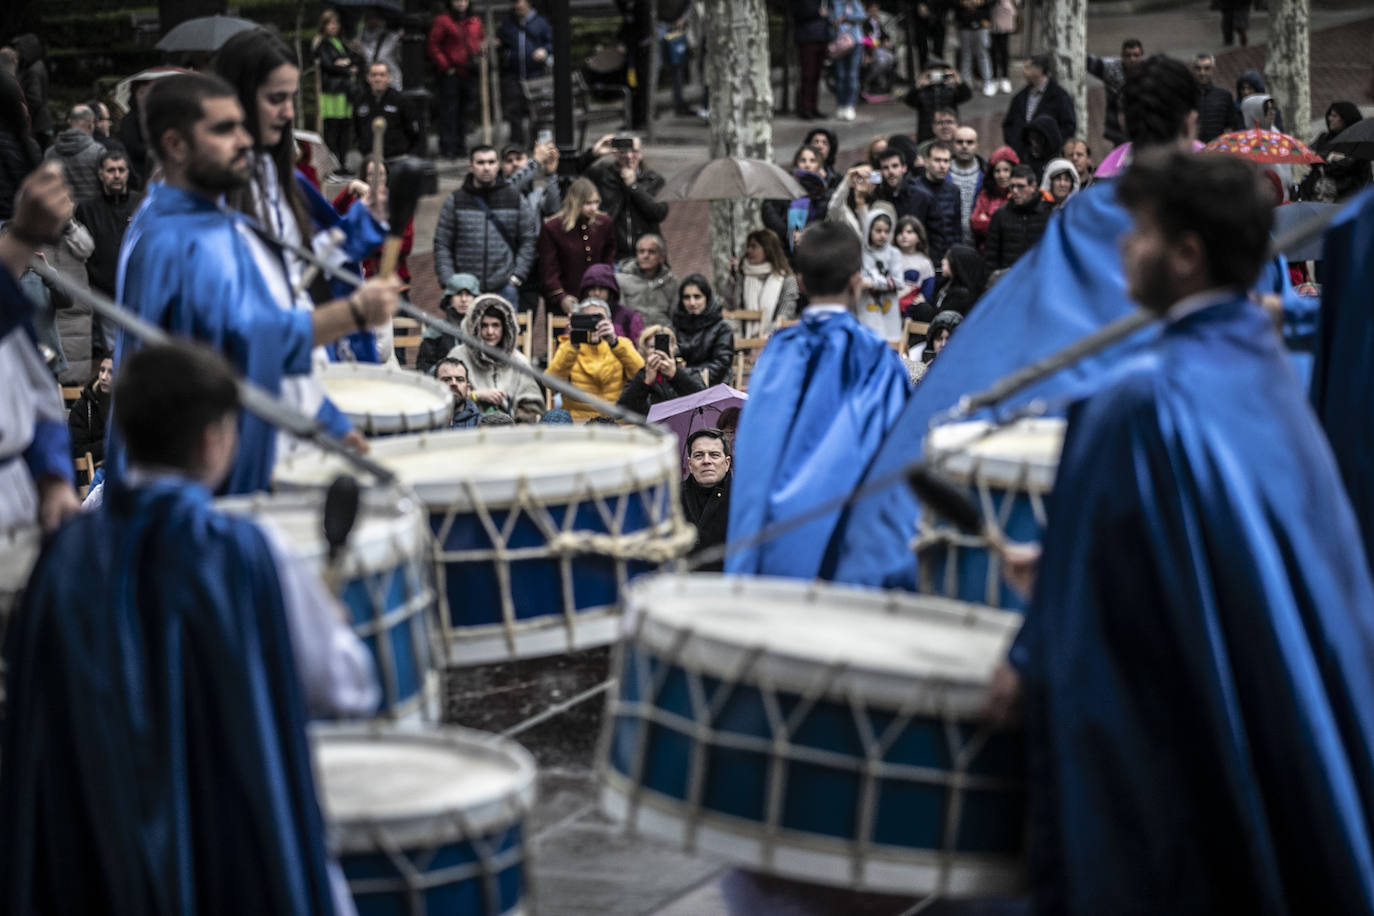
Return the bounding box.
[311,725,536,853]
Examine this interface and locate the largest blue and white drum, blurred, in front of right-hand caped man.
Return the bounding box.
[602,574,1026,895]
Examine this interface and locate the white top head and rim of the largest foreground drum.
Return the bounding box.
[625,574,1024,717]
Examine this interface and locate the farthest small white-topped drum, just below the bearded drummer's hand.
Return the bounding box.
[319,363,453,435]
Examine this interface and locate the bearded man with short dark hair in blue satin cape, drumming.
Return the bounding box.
[107,74,400,493]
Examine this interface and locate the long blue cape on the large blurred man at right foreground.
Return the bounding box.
[1011,295,1374,913]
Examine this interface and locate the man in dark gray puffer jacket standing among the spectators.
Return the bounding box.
[434,146,539,302]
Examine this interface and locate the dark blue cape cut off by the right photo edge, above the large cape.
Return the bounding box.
[1312,188,1374,567]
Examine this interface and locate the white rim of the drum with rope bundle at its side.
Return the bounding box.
[273,424,680,509]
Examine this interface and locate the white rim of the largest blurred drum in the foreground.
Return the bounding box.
[622,573,1024,718]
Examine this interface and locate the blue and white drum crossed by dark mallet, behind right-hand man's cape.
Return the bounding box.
[912,419,1063,611]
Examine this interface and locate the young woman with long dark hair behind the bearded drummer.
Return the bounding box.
[212,29,390,444]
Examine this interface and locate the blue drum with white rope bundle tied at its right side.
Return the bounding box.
[276,426,694,665]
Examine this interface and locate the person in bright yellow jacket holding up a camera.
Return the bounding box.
[548,299,644,423]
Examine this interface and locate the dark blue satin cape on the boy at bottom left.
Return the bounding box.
[0,482,333,915]
